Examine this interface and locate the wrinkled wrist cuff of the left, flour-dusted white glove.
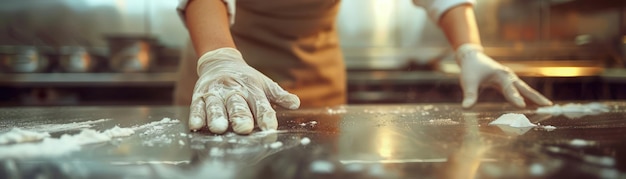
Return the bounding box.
[196,47,247,76]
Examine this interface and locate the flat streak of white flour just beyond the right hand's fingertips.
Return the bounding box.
[537,103,610,115]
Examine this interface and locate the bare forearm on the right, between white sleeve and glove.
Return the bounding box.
[439,4,481,50]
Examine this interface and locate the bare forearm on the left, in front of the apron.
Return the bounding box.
[185,0,235,56]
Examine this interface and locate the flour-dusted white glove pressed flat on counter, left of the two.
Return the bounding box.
[189,48,300,134]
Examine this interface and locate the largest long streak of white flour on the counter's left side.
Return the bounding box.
[0,118,178,158]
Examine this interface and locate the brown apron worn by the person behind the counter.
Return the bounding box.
[174,0,346,108]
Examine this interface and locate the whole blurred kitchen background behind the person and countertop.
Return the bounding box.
[0,0,626,106]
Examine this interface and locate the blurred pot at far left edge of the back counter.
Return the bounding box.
[0,46,48,73]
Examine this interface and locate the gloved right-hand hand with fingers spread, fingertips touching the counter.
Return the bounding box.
[456,44,552,108]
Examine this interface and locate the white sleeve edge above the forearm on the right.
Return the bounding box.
[413,0,476,23]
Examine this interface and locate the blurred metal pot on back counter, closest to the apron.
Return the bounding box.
[106,35,155,72]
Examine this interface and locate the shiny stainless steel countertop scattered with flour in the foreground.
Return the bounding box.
[0,101,626,178]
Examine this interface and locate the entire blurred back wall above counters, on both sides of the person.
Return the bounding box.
[0,0,626,64]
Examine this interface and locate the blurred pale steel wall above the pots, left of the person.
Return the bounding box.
[0,0,187,46]
